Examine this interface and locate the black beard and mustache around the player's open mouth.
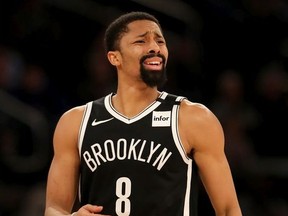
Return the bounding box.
[140,53,167,87]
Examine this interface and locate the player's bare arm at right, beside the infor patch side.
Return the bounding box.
[180,101,242,216]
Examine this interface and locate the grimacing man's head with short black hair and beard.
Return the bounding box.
[104,12,168,87]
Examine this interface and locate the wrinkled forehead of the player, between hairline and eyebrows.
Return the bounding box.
[128,20,162,36]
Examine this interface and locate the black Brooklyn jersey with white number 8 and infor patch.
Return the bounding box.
[79,92,200,216]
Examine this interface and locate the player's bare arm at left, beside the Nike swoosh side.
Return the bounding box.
[45,107,84,216]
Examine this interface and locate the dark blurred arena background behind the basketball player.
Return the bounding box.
[0,0,288,216]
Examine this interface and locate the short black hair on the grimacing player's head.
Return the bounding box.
[104,11,162,53]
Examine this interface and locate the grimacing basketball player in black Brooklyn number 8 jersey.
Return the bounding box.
[45,12,241,216]
